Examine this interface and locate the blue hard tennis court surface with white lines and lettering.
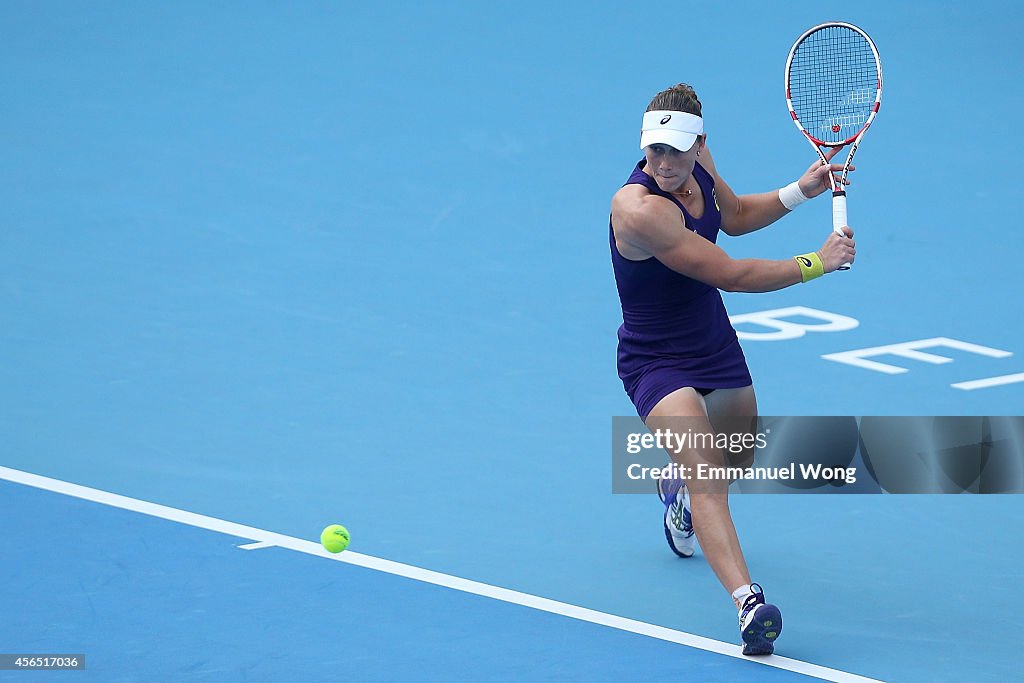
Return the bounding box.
[0,2,1024,682]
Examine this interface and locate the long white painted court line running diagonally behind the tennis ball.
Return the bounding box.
[0,466,882,683]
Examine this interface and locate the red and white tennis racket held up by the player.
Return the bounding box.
[785,22,882,270]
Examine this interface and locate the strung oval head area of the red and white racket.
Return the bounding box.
[788,27,879,144]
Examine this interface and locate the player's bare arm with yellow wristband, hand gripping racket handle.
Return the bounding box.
[611,185,856,292]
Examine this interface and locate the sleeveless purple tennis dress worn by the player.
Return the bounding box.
[608,160,752,419]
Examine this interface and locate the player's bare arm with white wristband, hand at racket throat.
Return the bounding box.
[697,145,854,237]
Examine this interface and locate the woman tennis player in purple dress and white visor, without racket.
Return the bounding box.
[610,84,856,654]
